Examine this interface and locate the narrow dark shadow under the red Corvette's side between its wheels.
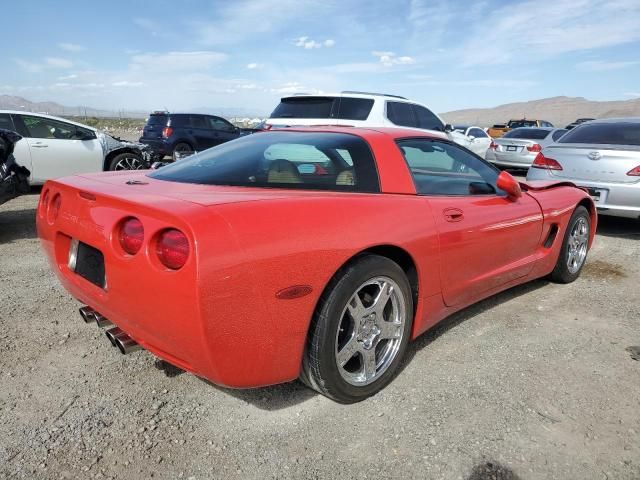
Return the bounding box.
[398,278,549,373]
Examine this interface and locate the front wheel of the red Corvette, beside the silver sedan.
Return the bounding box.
[549,206,591,283]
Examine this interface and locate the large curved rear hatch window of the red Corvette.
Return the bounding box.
[149,131,380,193]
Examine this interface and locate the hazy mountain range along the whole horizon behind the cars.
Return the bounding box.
[0,95,640,127]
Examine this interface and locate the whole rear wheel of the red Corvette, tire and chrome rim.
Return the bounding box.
[301,255,413,403]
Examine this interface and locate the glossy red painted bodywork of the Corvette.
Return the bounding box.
[37,127,596,387]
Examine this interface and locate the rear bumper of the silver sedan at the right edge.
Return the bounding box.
[527,168,640,218]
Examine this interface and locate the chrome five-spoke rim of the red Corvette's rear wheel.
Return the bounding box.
[335,277,407,387]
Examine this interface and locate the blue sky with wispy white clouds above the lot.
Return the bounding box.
[0,0,640,115]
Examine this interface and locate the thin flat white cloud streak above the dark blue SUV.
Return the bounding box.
[131,51,227,72]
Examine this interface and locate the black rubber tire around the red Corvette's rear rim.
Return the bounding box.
[300,255,413,403]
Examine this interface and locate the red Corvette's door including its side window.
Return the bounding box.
[398,138,542,306]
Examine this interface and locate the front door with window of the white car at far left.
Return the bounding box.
[14,114,104,184]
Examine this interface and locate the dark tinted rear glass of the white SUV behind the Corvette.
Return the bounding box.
[271,97,373,120]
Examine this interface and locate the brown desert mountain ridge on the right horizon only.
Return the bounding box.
[442,97,640,127]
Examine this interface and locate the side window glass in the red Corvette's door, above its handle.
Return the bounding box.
[398,139,502,195]
